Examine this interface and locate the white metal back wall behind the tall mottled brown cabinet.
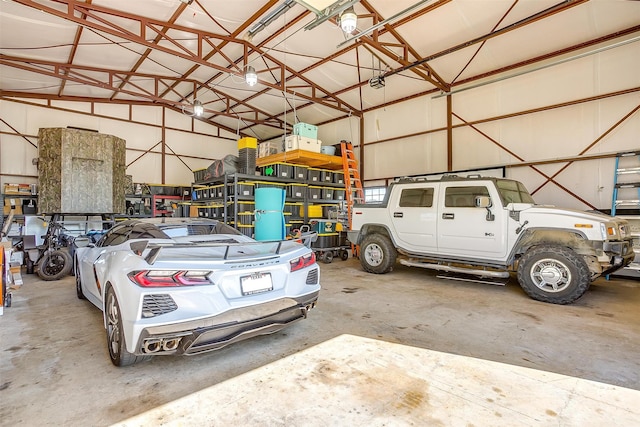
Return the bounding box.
[0,100,237,189]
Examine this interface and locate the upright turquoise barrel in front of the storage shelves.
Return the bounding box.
[255,188,286,241]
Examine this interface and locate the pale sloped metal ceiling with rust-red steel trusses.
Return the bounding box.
[0,0,640,139]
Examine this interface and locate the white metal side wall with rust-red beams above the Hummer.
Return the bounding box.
[364,42,640,209]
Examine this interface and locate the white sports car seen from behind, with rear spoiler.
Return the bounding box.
[74,218,320,366]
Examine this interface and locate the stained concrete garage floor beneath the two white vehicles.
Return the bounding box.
[0,259,640,426]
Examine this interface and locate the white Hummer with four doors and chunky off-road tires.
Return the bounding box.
[348,176,634,304]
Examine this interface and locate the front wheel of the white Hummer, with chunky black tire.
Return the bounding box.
[518,245,591,304]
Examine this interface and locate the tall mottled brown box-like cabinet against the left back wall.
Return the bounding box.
[38,128,126,214]
